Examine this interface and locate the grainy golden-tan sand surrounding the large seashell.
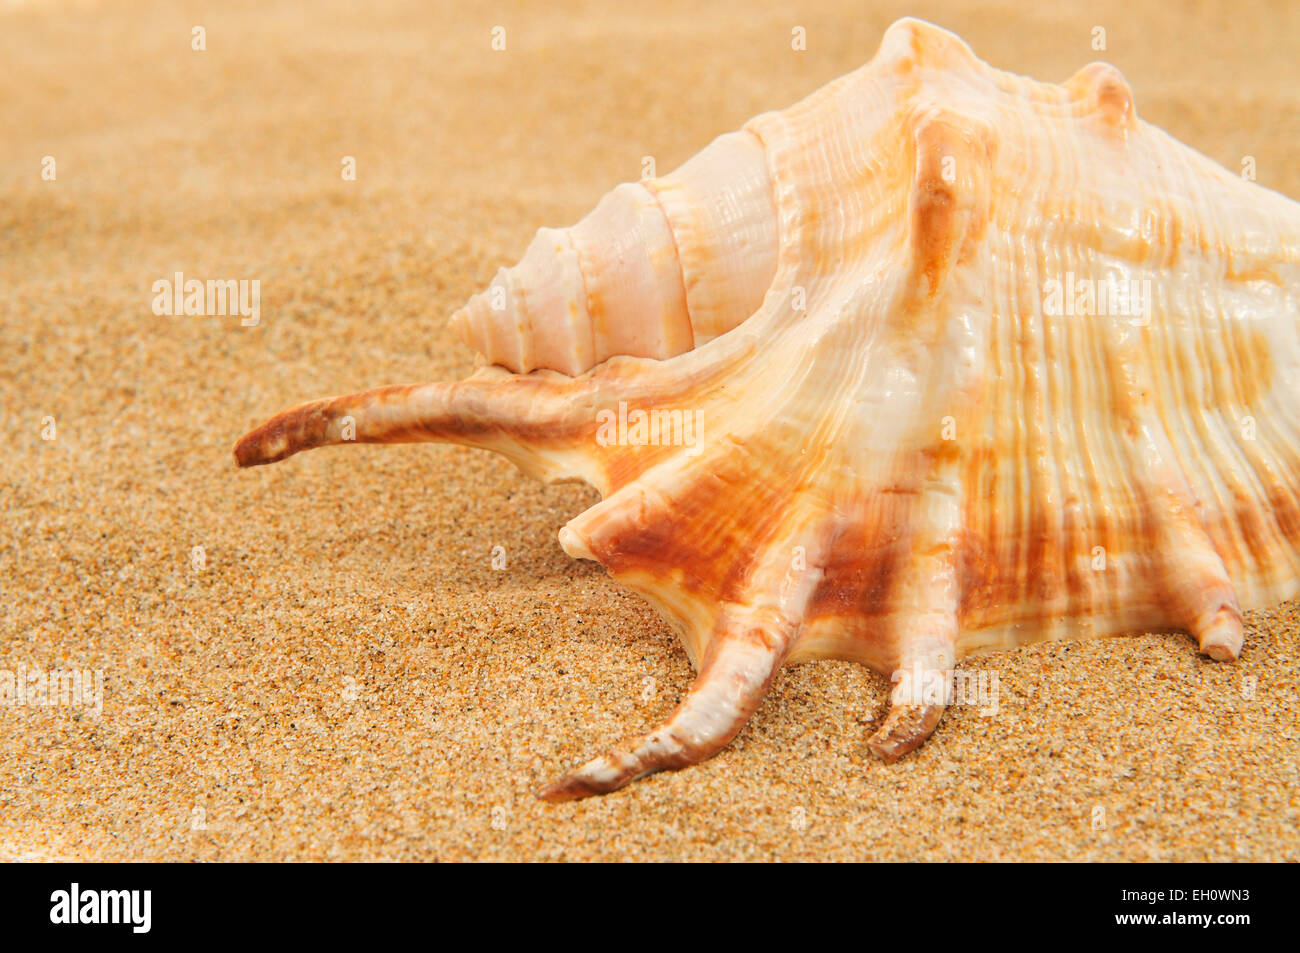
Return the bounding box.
[0,0,1300,861]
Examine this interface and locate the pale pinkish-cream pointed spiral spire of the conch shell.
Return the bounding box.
[451,130,777,376]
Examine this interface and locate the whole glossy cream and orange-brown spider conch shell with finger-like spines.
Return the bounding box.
[235,20,1300,800]
